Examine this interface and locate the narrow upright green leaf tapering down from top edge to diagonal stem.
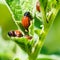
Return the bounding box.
[39,0,47,27]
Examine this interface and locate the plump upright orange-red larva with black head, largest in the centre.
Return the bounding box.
[22,12,32,31]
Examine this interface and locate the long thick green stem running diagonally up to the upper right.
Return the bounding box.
[30,2,59,60]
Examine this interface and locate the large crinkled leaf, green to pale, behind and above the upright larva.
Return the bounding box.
[6,0,36,21]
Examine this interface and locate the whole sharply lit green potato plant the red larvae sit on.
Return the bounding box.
[1,0,60,60]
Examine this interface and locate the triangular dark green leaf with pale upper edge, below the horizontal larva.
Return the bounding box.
[11,37,33,54]
